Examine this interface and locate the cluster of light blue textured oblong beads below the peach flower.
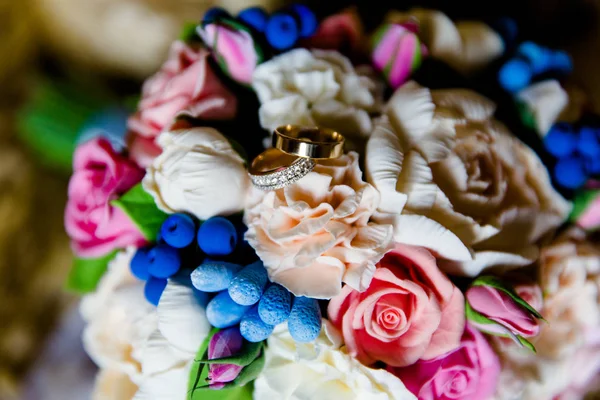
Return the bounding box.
[191,259,321,343]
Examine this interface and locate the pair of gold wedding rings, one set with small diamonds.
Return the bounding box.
[248,125,344,190]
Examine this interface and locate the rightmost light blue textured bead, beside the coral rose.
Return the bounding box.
[288,297,321,343]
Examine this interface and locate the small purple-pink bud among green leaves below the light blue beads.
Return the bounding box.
[208,327,244,389]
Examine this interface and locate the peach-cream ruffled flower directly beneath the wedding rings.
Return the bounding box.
[244,152,392,299]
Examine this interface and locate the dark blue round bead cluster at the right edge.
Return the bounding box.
[544,122,600,189]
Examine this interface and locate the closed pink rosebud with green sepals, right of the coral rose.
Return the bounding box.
[466,276,542,347]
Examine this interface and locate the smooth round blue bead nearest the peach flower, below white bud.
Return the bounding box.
[197,217,237,257]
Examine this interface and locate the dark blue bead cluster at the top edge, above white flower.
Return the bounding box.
[203,4,318,52]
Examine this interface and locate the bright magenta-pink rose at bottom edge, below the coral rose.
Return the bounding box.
[389,324,500,400]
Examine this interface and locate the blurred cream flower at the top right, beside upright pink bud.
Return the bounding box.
[386,8,504,73]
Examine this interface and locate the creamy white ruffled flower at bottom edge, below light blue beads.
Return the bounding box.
[254,320,416,400]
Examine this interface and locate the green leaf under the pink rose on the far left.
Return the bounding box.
[66,250,117,294]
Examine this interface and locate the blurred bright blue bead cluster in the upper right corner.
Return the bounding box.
[498,42,573,93]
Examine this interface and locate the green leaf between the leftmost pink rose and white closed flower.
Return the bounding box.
[111,183,168,242]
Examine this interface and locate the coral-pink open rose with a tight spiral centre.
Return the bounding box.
[328,244,465,367]
